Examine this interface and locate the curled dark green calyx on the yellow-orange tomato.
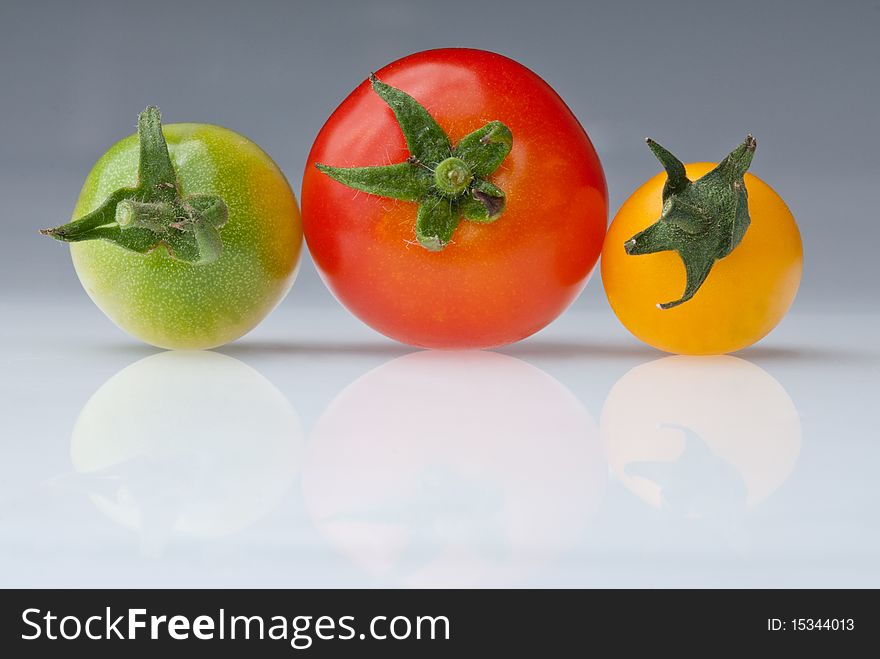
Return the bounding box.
[623,135,758,309]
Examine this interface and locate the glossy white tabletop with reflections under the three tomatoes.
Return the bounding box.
[0,300,880,587]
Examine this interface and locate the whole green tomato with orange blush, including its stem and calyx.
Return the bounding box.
[45,108,302,349]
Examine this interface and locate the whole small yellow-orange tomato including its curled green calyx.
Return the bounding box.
[602,137,803,355]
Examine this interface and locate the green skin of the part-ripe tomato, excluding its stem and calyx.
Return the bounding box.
[71,124,302,349]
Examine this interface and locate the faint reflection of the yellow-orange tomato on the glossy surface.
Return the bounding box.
[601,356,801,517]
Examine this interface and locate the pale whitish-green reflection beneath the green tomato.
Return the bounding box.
[70,352,302,549]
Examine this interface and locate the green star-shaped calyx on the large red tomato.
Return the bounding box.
[316,75,513,252]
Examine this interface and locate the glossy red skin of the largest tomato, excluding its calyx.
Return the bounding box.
[302,48,607,348]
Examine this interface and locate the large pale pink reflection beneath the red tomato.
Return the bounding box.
[303,351,607,587]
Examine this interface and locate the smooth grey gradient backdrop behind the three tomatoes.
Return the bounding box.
[0,0,880,311]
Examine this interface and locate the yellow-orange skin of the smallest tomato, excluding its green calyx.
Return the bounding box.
[602,163,803,355]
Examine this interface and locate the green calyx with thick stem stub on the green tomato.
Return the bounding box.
[40,107,229,264]
